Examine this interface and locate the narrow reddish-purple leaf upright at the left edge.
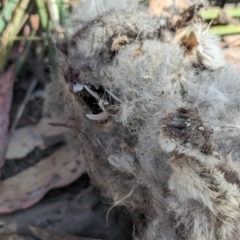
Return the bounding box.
[0,65,15,168]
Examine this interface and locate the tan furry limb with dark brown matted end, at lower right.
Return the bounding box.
[160,109,240,240]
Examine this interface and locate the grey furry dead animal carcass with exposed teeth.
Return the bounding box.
[46,1,240,240]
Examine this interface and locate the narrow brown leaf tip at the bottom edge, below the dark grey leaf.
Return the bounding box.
[29,226,97,240]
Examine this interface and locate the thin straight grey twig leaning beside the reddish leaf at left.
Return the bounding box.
[0,78,37,169]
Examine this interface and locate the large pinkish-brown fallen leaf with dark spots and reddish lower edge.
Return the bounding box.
[0,146,85,213]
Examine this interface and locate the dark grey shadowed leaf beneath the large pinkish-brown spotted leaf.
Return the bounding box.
[0,188,132,240]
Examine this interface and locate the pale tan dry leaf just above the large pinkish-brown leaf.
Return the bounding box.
[6,118,66,159]
